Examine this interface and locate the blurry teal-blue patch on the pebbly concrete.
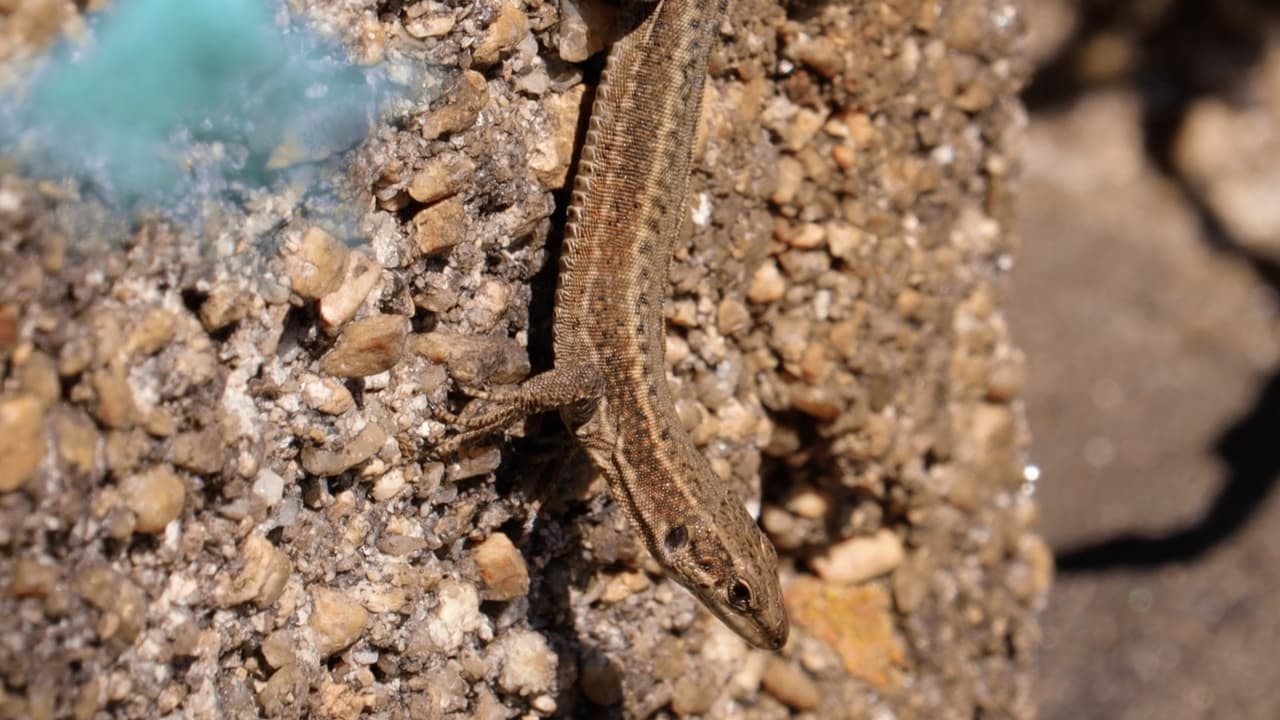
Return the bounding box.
[0,0,387,206]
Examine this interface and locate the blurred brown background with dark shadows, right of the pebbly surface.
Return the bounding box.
[1010,3,1280,720]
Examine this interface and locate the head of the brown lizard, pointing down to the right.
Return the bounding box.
[654,498,790,650]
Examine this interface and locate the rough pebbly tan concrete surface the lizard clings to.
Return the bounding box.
[0,0,1051,719]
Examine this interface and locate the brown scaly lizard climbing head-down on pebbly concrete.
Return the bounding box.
[442,0,788,650]
